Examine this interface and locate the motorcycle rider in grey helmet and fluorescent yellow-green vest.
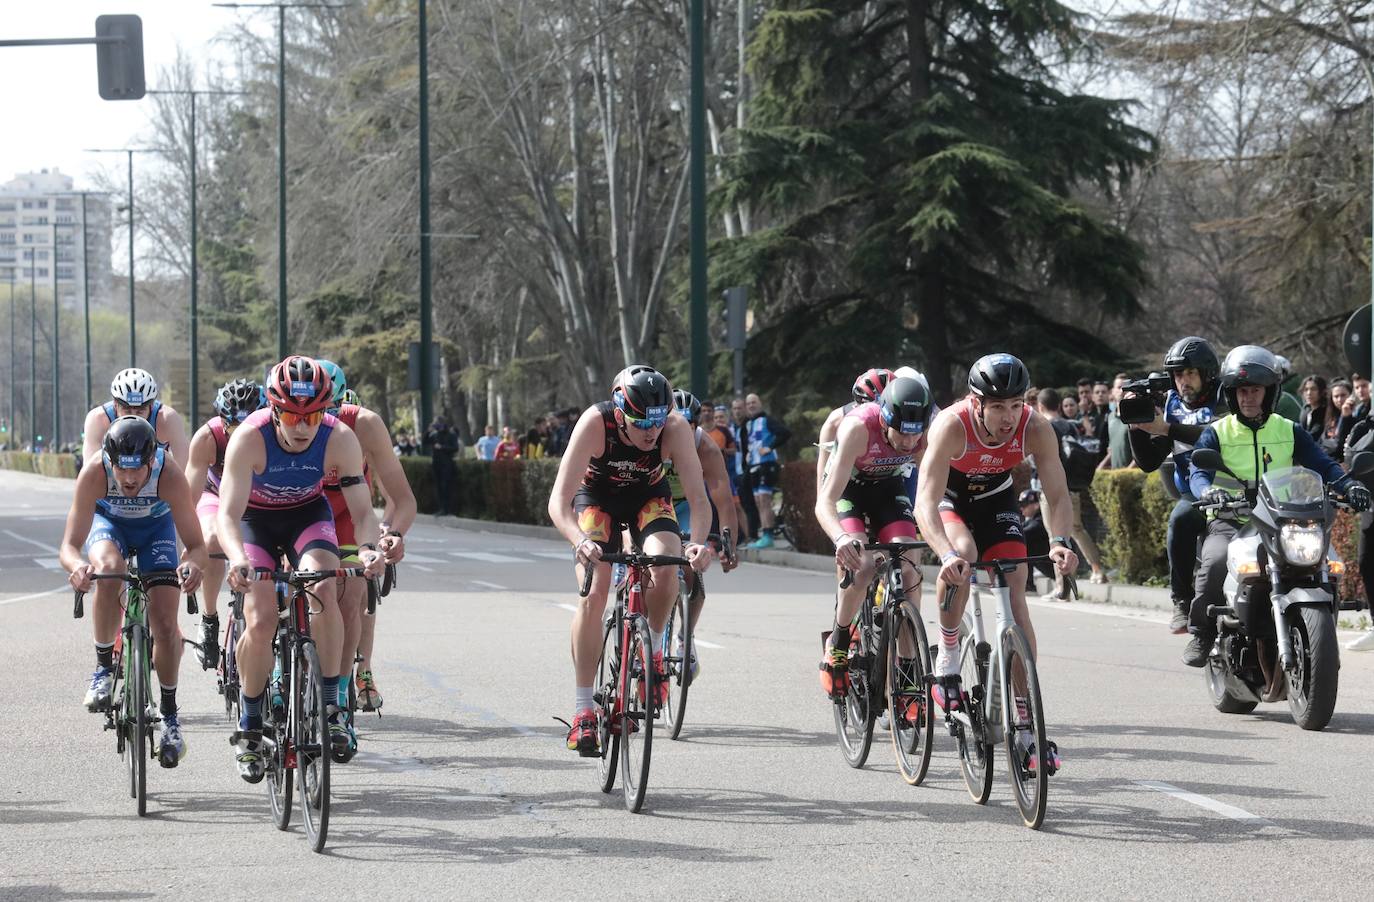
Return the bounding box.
[1183,345,1370,667]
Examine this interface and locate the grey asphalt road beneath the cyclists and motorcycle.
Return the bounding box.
[0,472,1374,899]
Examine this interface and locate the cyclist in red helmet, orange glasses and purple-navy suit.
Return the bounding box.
[214,356,383,782]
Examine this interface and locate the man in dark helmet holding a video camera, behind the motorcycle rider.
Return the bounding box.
[1124,336,1227,635]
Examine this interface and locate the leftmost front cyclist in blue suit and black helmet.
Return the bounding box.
[59,417,206,767]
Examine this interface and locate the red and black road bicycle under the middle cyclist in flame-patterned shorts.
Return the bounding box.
[581,551,690,813]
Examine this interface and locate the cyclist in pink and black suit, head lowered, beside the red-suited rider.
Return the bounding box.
[816,378,934,699]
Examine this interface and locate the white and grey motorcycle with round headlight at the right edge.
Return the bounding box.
[1193,448,1374,730]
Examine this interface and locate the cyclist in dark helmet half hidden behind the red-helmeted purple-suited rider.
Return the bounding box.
[185,380,267,667]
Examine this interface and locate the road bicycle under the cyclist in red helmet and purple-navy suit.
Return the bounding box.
[235,567,365,853]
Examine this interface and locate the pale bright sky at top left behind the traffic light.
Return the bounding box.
[0,0,251,190]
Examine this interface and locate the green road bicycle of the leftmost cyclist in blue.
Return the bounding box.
[71,563,199,817]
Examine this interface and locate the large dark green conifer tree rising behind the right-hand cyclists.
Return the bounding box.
[713,0,1153,393]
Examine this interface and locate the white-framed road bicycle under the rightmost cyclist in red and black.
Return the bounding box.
[929,554,1077,831]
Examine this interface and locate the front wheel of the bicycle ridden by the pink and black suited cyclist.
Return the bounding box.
[888,602,936,787]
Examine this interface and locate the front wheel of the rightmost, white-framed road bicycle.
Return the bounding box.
[1002,624,1050,831]
